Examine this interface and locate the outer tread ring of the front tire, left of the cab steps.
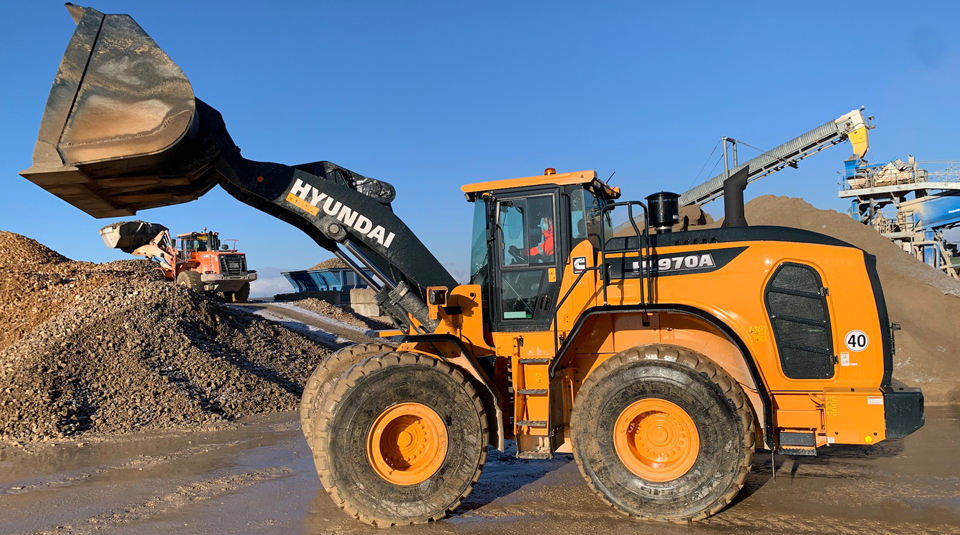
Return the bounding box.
[311,352,489,527]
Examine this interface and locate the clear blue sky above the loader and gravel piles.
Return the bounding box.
[0,0,960,296]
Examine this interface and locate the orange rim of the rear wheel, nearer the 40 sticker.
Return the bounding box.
[613,398,700,482]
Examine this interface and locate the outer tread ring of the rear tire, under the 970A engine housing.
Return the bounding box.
[571,344,756,522]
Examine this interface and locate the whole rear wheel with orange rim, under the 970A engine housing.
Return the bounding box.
[571,345,754,522]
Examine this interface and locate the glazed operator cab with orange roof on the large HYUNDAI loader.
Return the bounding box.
[461,169,620,332]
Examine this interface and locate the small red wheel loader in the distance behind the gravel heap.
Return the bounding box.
[100,221,257,303]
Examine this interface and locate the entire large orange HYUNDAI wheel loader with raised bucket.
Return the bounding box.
[22,5,923,526]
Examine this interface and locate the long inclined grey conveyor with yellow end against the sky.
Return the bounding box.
[680,108,873,206]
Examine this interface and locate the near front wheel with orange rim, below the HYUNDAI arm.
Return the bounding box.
[314,353,487,527]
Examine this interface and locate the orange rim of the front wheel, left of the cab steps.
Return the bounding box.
[367,403,447,485]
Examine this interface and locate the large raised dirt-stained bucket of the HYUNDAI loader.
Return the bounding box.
[20,4,216,217]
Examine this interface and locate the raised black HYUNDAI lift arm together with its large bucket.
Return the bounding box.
[20,4,456,332]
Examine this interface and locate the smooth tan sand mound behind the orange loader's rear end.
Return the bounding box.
[746,195,960,403]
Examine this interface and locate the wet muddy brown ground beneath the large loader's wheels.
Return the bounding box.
[0,407,960,535]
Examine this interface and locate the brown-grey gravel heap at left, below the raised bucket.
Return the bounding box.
[0,233,327,442]
